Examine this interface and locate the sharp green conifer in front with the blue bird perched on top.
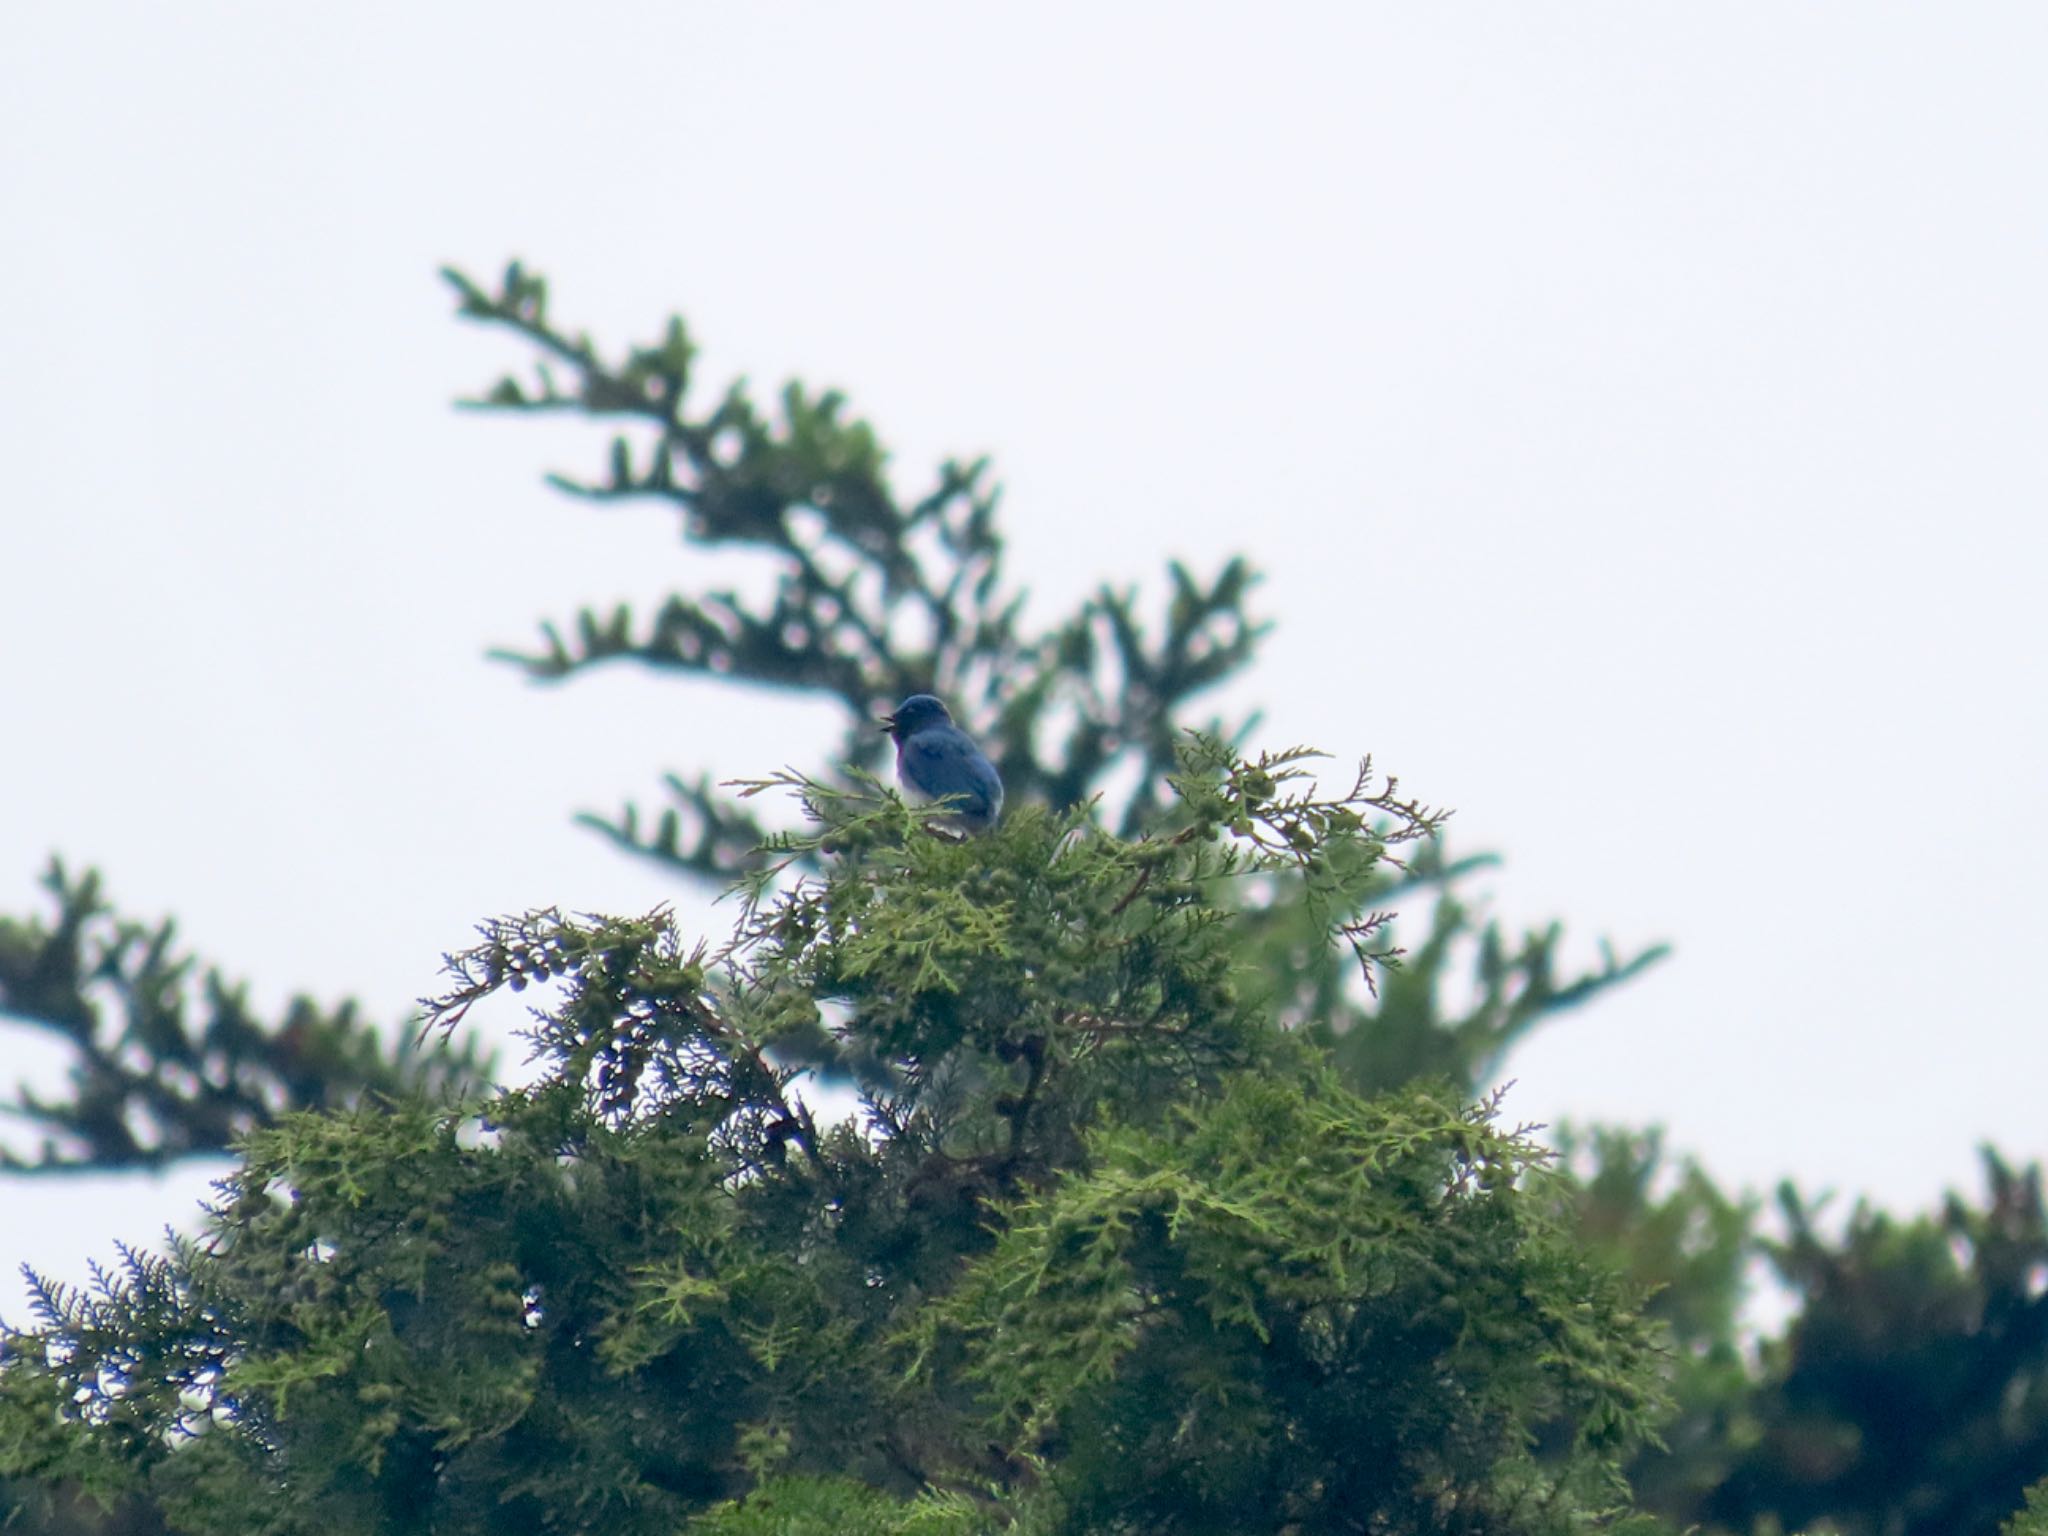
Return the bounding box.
[0,737,1659,1534]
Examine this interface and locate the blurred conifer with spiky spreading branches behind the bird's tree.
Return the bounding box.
[0,264,1663,1171]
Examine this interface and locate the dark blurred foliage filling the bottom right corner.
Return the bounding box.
[1556,1130,2048,1536]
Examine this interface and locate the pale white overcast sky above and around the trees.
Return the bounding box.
[0,0,2048,1321]
